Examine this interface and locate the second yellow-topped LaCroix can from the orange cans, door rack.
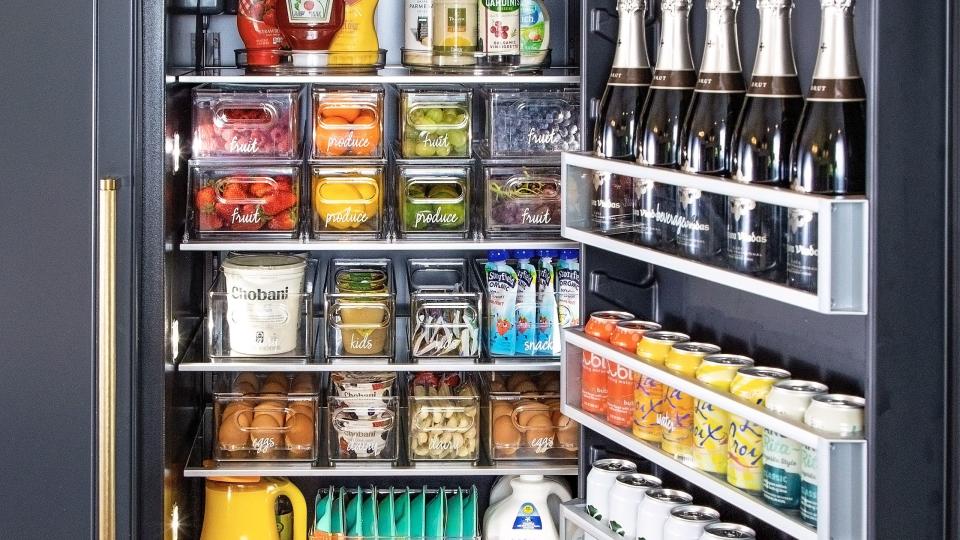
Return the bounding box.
[660,342,720,465]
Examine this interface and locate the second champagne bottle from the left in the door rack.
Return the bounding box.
[634,0,697,248]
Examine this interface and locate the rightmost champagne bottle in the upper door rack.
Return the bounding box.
[787,0,867,291]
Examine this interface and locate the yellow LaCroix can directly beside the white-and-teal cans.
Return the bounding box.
[727,367,790,492]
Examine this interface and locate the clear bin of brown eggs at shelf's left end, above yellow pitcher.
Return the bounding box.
[213,393,318,462]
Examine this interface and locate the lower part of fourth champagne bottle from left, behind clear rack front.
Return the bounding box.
[726,197,783,273]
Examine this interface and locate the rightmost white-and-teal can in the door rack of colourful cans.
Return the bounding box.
[800,394,866,525]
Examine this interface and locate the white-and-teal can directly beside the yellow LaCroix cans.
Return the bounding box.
[763,379,827,508]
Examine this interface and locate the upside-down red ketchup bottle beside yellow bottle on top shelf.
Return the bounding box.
[277,0,346,66]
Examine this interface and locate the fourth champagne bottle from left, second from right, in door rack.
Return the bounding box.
[726,0,803,278]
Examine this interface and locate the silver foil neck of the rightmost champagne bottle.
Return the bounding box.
[813,6,860,79]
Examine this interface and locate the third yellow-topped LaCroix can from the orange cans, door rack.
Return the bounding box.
[693,354,753,474]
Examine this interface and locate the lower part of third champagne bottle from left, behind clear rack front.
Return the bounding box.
[677,187,724,261]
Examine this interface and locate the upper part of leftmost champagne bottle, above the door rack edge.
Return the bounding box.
[594,0,652,161]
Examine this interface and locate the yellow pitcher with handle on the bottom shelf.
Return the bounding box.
[200,477,307,540]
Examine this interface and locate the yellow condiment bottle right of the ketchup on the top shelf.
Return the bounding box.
[330,0,380,66]
